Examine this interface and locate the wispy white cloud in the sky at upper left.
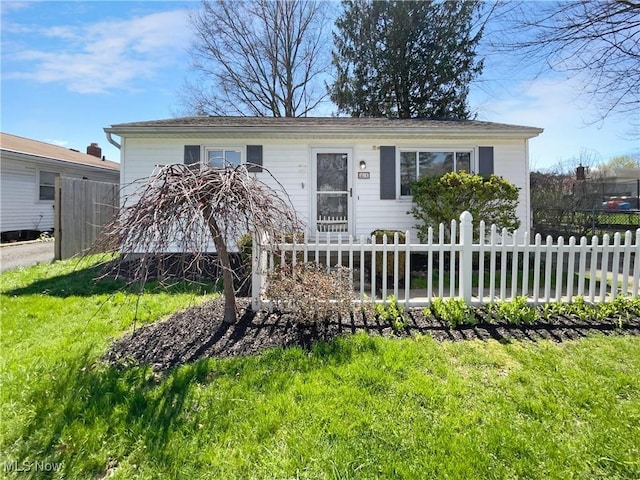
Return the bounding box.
[5,10,190,93]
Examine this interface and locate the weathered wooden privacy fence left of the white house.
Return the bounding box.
[54,177,120,260]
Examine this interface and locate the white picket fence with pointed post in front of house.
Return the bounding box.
[252,212,640,308]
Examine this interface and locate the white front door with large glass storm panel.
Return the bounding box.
[312,148,353,233]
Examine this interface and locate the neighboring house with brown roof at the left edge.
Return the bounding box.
[0,133,120,240]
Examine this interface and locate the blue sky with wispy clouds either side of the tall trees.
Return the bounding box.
[0,1,640,169]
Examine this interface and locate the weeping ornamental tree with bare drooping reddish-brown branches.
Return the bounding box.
[100,164,300,323]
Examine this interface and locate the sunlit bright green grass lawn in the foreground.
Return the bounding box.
[0,262,640,479]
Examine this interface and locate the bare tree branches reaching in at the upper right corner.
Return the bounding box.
[493,0,640,122]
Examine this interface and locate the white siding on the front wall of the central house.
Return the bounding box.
[122,136,529,246]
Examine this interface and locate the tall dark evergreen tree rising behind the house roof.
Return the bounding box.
[329,0,483,119]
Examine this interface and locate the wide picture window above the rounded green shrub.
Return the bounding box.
[400,150,471,196]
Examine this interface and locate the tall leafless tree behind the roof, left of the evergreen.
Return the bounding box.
[183,0,330,117]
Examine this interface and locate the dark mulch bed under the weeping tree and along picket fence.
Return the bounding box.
[106,299,640,370]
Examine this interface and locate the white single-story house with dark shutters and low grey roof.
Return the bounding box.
[105,117,542,242]
